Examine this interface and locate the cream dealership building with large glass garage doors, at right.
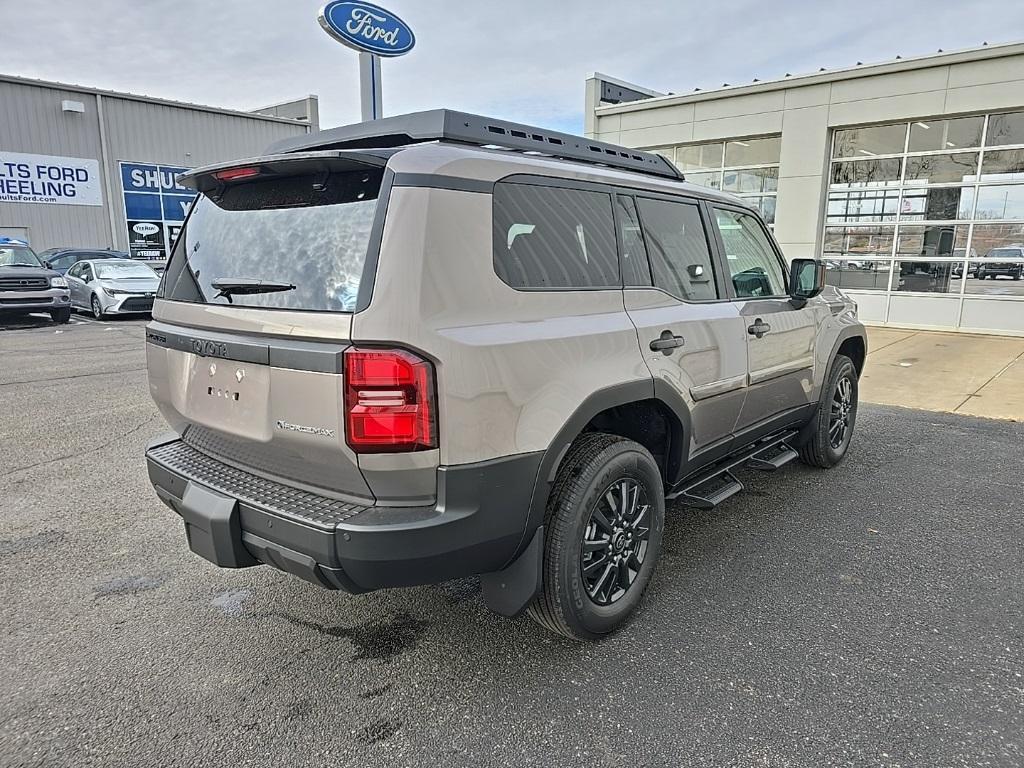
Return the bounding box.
[585,44,1024,335]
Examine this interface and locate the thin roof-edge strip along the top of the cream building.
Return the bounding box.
[595,42,1024,116]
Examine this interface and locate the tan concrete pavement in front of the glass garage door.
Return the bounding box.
[860,328,1024,421]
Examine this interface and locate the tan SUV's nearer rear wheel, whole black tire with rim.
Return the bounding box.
[527,432,665,640]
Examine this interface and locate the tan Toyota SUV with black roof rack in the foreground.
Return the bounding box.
[146,111,865,638]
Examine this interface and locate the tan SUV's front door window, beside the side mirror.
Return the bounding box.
[715,208,785,299]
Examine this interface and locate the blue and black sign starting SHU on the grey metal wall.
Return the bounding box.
[121,163,196,259]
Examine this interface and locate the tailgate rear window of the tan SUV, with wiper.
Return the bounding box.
[162,168,383,312]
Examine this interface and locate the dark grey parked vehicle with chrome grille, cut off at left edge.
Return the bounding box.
[0,238,71,323]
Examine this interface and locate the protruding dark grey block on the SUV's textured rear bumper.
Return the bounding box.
[178,482,259,568]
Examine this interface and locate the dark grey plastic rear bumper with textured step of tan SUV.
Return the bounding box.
[146,435,543,592]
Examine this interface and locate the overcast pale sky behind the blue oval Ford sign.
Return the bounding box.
[6,0,1024,132]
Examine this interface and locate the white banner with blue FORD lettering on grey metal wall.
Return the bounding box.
[0,151,103,206]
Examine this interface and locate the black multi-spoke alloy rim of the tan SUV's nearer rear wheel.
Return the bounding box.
[580,477,650,605]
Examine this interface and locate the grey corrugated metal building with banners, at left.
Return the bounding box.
[0,75,318,259]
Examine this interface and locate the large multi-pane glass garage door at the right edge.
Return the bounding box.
[822,112,1024,334]
